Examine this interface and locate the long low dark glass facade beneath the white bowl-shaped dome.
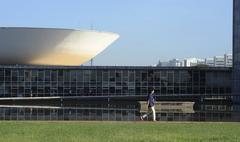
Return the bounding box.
[0,66,232,98]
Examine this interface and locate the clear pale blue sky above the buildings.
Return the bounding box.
[0,0,232,65]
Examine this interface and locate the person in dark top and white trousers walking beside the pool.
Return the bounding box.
[140,89,156,121]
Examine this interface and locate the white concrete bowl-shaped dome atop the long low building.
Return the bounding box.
[0,28,119,66]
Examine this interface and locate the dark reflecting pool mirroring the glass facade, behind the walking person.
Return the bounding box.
[0,102,240,122]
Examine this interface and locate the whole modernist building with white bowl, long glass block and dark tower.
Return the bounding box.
[0,0,240,104]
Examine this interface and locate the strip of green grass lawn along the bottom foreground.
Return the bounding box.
[0,121,240,142]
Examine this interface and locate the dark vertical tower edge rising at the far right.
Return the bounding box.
[232,0,240,102]
